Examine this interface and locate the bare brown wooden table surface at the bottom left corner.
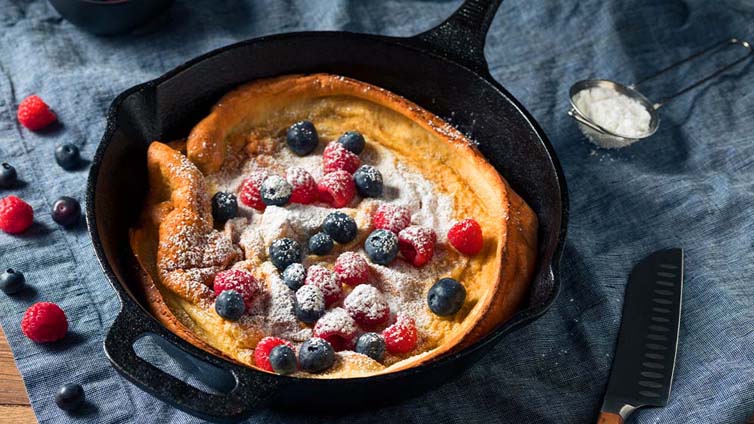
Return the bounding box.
[0,329,37,424]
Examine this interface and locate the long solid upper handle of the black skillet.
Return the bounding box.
[409,0,502,75]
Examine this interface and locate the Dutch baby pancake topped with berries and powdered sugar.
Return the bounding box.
[131,74,537,378]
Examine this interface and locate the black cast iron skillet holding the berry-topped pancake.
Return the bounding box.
[86,0,568,421]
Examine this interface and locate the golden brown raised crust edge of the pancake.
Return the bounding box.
[132,74,537,377]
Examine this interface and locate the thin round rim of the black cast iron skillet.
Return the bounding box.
[86,31,568,384]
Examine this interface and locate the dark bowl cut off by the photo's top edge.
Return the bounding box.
[50,0,173,35]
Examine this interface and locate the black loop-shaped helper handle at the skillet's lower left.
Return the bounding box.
[104,299,280,422]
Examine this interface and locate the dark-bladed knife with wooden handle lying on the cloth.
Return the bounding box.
[598,249,683,424]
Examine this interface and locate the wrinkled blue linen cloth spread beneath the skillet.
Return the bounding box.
[0,0,754,424]
